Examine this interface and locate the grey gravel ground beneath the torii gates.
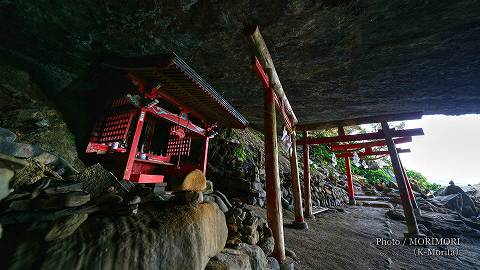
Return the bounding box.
[251,206,480,269]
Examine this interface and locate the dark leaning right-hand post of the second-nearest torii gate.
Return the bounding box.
[382,122,420,238]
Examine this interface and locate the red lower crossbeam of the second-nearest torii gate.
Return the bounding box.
[298,128,424,144]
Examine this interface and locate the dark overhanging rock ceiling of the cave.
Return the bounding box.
[0,0,480,126]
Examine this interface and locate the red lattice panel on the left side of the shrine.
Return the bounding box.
[97,112,135,143]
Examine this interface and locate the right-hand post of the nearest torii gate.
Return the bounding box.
[290,131,308,229]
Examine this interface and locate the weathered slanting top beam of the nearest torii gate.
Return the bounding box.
[245,25,298,125]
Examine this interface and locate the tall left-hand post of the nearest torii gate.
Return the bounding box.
[263,86,285,263]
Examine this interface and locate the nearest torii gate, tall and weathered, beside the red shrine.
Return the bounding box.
[246,26,308,269]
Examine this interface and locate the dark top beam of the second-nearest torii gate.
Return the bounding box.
[297,112,423,130]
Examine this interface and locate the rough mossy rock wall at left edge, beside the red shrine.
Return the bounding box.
[0,64,85,169]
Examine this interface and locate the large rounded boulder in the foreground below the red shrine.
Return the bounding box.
[0,203,227,270]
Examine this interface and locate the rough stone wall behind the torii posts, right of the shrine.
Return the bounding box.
[207,129,348,210]
